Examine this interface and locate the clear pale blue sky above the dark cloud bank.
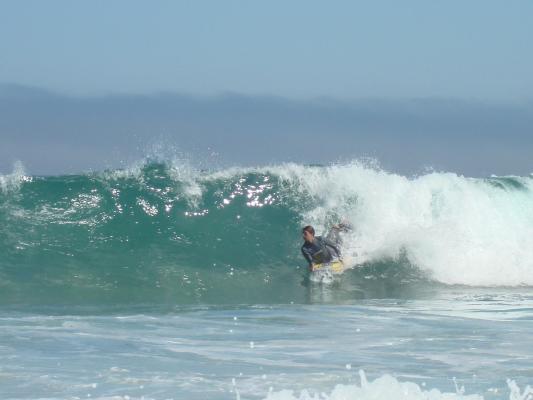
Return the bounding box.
[0,0,533,100]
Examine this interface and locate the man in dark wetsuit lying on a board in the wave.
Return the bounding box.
[302,224,344,271]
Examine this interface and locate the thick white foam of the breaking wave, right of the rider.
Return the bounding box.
[270,163,533,286]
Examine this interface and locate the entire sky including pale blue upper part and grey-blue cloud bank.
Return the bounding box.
[0,0,533,175]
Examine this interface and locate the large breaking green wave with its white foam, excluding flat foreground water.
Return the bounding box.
[0,163,533,304]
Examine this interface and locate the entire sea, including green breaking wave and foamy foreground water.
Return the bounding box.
[0,161,533,400]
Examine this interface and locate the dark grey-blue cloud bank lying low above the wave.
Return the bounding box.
[0,85,533,175]
